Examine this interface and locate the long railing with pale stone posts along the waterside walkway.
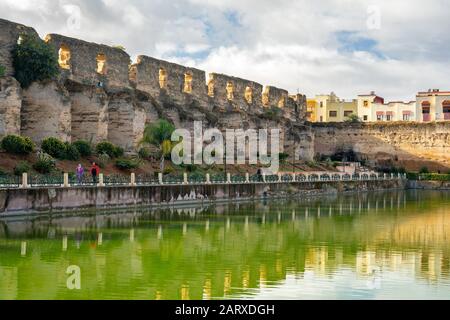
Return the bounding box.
[0,172,407,189]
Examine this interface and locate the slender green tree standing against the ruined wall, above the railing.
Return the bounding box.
[141,119,175,172]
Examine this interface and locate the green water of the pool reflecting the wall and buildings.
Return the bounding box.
[0,191,450,299]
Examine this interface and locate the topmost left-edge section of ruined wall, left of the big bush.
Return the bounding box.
[0,19,38,76]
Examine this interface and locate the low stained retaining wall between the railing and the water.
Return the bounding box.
[0,180,406,216]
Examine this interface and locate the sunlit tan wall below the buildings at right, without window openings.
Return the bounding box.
[312,122,450,168]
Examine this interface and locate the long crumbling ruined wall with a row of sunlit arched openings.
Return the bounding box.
[0,19,311,157]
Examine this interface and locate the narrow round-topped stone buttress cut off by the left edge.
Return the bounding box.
[0,77,22,136]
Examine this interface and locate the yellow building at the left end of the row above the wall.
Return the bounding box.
[307,92,358,122]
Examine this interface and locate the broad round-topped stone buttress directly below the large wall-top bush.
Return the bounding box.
[21,81,71,142]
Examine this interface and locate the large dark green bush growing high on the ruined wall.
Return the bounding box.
[12,34,59,88]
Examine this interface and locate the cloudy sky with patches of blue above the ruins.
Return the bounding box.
[0,0,450,100]
